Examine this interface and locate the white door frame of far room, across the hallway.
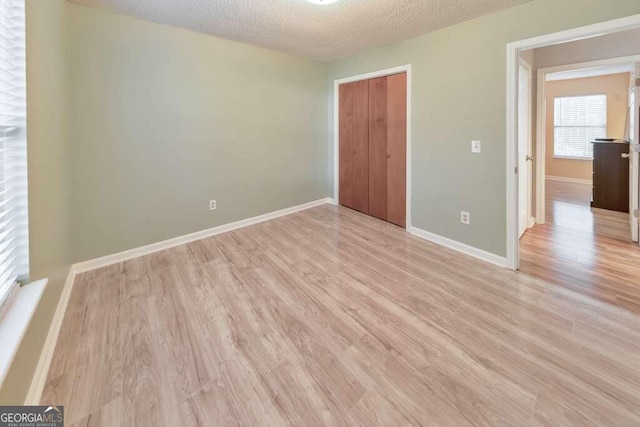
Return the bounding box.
[535,55,640,224]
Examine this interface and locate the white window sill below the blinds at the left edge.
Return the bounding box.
[0,279,47,388]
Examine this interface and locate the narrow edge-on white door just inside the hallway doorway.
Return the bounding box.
[518,61,533,237]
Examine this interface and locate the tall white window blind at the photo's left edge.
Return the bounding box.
[0,0,29,315]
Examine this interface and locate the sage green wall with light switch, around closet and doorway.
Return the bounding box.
[329,0,640,256]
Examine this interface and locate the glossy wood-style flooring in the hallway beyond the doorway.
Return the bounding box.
[520,180,640,313]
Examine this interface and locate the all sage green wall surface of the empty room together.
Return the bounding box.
[0,0,640,404]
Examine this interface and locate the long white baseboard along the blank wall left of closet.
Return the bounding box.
[74,197,333,274]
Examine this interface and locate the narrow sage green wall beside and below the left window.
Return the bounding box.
[0,0,71,405]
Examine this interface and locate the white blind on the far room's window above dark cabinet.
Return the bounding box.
[553,95,607,159]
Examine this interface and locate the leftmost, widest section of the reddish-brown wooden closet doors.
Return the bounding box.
[338,81,369,213]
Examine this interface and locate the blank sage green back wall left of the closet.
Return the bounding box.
[69,4,329,262]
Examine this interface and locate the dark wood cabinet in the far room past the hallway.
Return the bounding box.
[591,142,629,212]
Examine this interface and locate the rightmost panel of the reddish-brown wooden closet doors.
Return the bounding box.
[387,73,407,227]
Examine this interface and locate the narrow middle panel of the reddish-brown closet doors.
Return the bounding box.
[369,77,387,220]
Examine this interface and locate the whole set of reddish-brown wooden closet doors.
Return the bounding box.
[338,73,407,227]
